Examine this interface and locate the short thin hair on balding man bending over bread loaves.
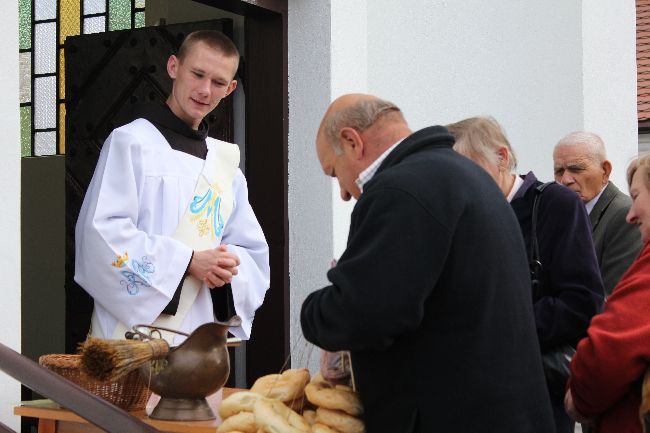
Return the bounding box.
[323,98,404,155]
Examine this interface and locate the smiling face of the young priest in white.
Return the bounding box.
[167,42,238,129]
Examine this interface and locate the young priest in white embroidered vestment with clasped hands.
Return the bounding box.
[75,31,269,343]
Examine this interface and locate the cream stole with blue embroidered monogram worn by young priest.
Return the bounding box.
[91,141,239,345]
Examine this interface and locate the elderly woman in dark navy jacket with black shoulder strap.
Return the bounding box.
[447,117,604,433]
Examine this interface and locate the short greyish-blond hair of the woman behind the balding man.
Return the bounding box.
[447,117,517,172]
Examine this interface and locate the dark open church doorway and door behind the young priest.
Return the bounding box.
[23,0,289,398]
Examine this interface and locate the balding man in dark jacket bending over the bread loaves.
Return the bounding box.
[301,94,554,433]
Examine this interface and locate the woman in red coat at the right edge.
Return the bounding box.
[565,155,650,433]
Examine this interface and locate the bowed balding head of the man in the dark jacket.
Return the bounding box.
[316,93,411,200]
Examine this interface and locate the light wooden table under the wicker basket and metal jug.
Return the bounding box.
[14,388,241,433]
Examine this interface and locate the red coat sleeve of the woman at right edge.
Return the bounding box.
[569,243,650,417]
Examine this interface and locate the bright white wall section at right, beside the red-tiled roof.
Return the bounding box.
[582,0,638,192]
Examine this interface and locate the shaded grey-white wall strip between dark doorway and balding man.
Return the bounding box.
[286,0,333,371]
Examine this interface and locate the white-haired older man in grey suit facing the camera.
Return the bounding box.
[553,131,642,294]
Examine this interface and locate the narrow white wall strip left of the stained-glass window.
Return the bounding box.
[0,0,20,430]
